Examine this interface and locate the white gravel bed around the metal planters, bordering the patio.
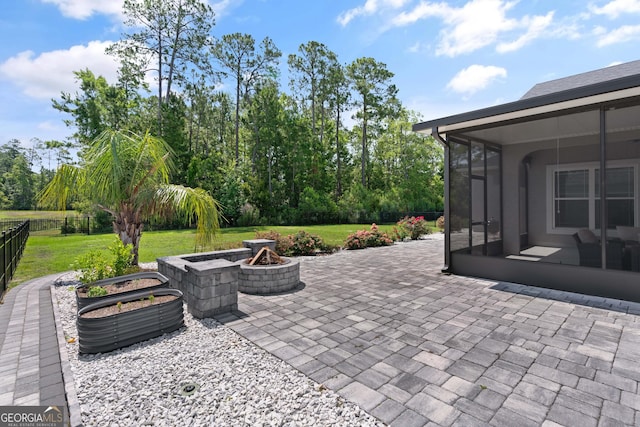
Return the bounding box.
[54,276,384,427]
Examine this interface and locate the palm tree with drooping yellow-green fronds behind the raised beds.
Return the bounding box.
[39,130,220,265]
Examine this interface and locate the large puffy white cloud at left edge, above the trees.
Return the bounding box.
[0,41,118,99]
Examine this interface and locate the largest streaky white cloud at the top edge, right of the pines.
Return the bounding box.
[391,0,554,57]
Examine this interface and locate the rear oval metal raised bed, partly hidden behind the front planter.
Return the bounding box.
[76,271,169,311]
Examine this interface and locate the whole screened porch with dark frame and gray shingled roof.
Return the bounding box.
[413,61,640,301]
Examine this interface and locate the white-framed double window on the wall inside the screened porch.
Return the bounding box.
[547,161,639,234]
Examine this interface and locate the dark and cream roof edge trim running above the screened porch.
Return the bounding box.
[413,61,640,134]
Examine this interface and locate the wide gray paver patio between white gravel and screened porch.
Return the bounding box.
[218,239,640,427]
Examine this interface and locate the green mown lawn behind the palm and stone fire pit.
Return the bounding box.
[9,224,393,288]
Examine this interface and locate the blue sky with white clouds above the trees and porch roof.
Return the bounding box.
[0,0,640,151]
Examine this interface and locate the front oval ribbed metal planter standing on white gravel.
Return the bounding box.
[76,288,184,353]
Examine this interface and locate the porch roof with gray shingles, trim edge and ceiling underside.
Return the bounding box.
[413,61,640,145]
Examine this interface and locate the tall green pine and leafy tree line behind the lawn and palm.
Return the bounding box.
[0,0,443,225]
